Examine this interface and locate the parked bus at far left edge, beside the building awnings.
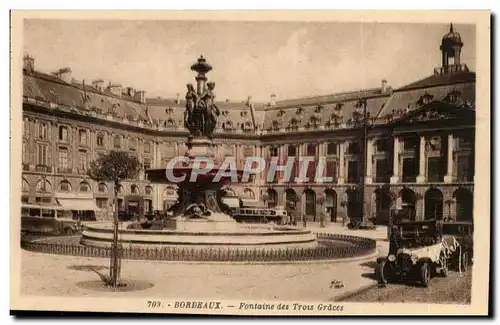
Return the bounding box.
[21,204,81,236]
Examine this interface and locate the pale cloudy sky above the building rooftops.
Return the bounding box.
[24,19,476,102]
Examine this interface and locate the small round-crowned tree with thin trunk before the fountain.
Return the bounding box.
[88,151,141,287]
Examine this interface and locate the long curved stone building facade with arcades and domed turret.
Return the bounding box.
[22,26,475,223]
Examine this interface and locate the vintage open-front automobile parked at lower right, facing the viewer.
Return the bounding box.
[377,220,461,287]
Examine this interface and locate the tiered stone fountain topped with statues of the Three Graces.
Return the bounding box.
[80,56,376,259]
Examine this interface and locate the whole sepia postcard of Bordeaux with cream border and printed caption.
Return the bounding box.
[11,11,490,316]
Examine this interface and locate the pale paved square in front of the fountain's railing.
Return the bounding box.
[17,225,387,301]
